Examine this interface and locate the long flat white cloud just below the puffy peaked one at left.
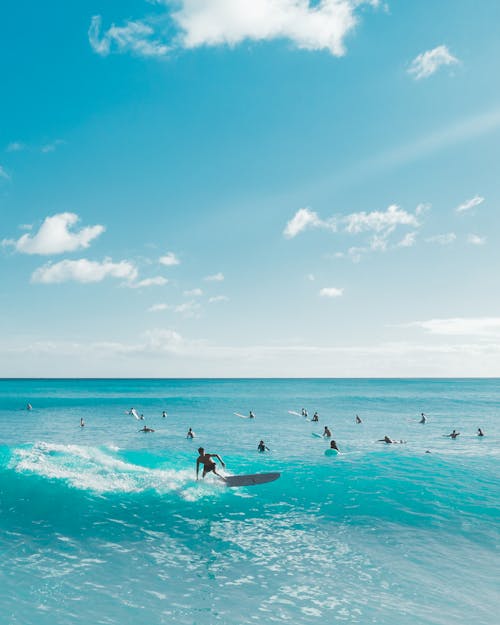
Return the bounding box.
[31,258,137,284]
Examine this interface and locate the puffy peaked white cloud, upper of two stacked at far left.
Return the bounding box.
[2,213,105,255]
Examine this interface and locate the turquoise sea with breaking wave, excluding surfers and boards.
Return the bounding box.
[0,380,500,625]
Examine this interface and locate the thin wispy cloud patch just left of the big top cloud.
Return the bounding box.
[88,15,170,57]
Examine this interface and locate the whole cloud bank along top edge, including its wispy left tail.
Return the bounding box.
[88,0,380,57]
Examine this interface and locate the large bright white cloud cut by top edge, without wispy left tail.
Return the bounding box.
[169,0,378,56]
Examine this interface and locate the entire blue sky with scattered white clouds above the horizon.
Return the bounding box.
[0,0,500,377]
